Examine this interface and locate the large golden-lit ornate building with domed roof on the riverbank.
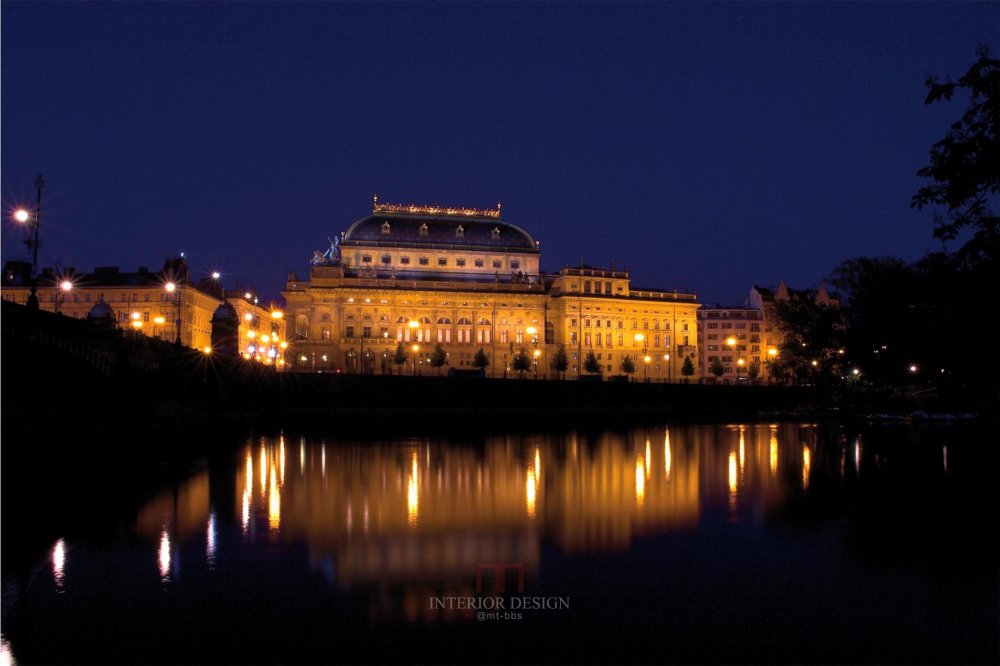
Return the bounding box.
[282,198,698,381]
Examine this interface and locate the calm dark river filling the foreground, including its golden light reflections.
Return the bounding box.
[2,423,1000,663]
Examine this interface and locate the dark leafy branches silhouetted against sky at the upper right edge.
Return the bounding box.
[911,47,1000,257]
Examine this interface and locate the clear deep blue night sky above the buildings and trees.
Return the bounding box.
[0,1,1000,302]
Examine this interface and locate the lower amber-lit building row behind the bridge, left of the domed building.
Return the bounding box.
[2,257,287,363]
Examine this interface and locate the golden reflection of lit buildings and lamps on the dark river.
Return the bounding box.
[131,424,820,618]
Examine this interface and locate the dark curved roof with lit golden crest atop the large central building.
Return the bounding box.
[343,205,538,253]
